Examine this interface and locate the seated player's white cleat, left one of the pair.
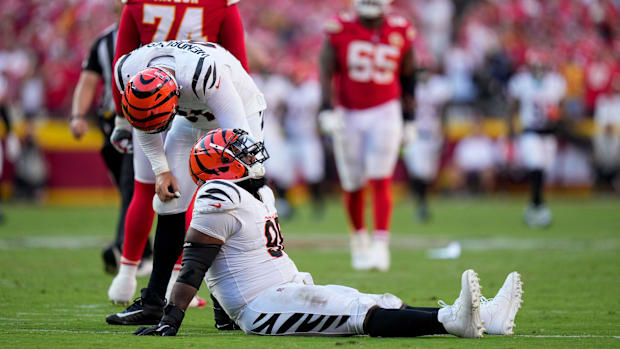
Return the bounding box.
[437,269,484,338]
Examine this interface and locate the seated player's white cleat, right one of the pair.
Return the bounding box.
[480,271,523,335]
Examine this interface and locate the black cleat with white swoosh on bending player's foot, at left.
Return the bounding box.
[105,288,166,326]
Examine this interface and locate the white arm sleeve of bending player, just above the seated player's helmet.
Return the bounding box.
[204,66,254,136]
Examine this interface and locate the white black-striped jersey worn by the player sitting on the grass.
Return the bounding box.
[191,180,298,321]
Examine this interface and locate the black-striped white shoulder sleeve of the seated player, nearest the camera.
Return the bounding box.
[190,180,241,242]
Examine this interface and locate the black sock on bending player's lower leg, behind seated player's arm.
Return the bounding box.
[148,212,185,299]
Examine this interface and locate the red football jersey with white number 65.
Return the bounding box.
[326,13,415,109]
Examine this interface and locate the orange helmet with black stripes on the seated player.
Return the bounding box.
[189,128,269,185]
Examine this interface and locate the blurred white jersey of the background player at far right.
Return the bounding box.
[508,72,566,130]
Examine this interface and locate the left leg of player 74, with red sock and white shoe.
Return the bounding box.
[108,132,155,303]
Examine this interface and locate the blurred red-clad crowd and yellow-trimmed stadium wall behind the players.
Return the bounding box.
[0,0,620,202]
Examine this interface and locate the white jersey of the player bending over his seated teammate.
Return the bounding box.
[114,40,267,129]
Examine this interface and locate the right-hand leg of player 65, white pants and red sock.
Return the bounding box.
[364,102,402,271]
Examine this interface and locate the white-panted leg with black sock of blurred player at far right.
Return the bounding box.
[519,132,551,228]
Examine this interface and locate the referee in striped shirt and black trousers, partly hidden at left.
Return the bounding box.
[70,17,152,274]
